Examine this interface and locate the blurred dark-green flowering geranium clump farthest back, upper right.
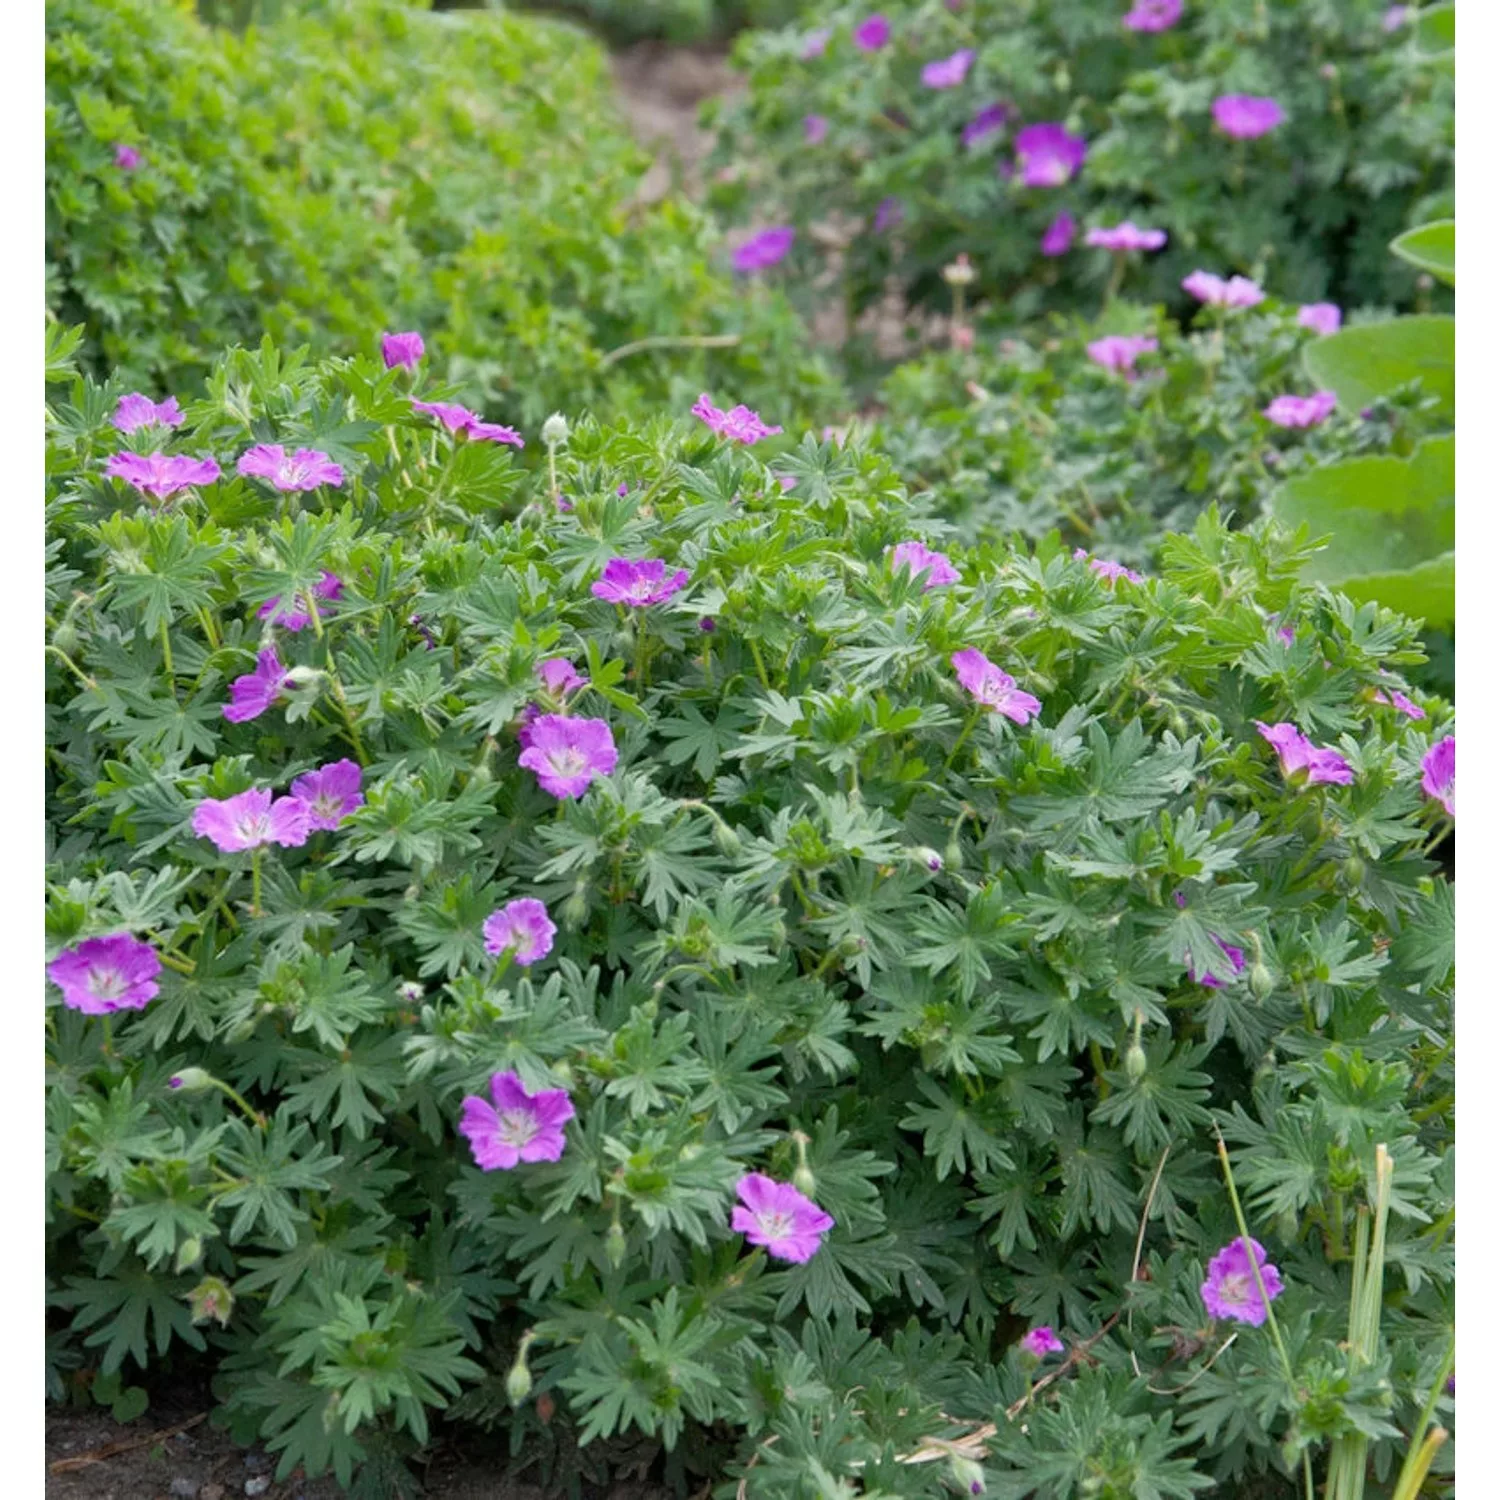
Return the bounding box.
[717,0,1452,343]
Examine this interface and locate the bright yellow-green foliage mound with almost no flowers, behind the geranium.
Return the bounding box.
[47,0,837,428]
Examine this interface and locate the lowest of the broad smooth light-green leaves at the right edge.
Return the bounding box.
[1271,438,1455,626]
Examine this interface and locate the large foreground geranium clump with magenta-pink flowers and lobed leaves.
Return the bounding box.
[47,330,1455,1500]
